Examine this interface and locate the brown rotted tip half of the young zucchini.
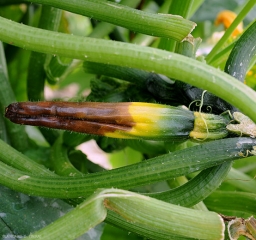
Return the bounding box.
[5,101,133,135]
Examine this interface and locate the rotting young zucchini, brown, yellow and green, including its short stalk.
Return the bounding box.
[5,102,228,140]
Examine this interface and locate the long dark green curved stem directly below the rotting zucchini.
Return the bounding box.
[0,138,255,199]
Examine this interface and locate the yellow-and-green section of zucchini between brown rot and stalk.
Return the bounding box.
[105,102,194,140]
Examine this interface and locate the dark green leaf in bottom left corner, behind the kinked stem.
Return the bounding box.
[0,186,103,240]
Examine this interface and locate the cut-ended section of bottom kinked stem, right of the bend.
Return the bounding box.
[105,191,224,239]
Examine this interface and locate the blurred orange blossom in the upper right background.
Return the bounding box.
[214,10,243,37]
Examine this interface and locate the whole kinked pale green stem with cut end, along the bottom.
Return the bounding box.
[24,189,225,240]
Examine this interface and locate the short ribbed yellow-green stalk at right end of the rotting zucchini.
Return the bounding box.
[189,112,228,140]
